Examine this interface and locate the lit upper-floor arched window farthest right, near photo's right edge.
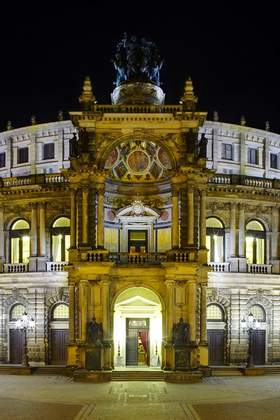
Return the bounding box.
[246,220,266,264]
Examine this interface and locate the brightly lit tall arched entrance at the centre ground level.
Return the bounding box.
[114,287,162,367]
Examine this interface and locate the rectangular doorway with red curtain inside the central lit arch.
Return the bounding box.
[126,318,149,366]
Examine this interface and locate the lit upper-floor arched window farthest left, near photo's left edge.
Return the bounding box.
[10,219,30,263]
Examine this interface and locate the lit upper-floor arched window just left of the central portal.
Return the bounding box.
[51,217,70,262]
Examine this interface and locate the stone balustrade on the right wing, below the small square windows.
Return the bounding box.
[208,174,280,188]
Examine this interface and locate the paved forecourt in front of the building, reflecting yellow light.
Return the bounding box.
[0,375,280,420]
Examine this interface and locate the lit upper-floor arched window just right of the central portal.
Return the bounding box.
[206,217,225,263]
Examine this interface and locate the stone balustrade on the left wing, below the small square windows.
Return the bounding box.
[0,174,68,188]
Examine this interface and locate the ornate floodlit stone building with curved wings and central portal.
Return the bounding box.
[0,37,280,371]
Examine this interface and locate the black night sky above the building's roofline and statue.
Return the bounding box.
[0,0,280,133]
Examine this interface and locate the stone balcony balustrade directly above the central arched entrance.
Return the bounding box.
[109,252,167,264]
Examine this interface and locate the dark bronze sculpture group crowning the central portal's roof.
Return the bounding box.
[113,33,163,86]
